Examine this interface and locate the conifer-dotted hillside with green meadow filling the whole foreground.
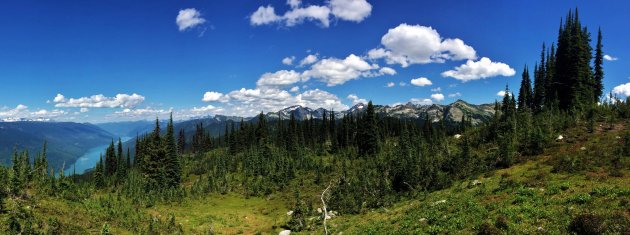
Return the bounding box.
[0,10,630,234]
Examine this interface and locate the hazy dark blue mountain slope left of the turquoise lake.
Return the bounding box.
[0,122,114,169]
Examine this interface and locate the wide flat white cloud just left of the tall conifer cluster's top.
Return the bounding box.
[442,57,516,82]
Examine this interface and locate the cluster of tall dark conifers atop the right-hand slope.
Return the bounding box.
[518,9,604,114]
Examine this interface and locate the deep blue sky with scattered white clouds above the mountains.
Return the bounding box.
[0,0,630,122]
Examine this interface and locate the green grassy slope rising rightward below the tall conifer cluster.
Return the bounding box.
[331,122,630,234]
